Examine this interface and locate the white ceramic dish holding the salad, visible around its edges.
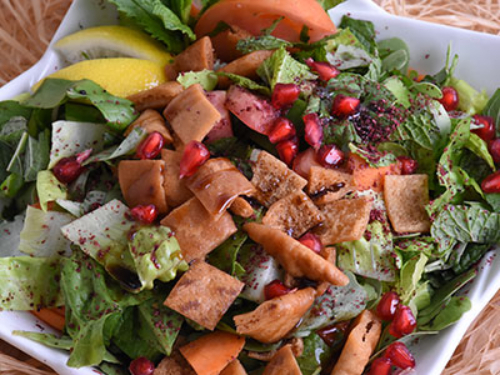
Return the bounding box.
[0,0,500,375]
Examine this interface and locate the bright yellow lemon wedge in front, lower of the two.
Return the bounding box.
[32,58,167,98]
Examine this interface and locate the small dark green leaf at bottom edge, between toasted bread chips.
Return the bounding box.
[297,333,333,375]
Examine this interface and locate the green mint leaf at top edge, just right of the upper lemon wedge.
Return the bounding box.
[110,0,196,53]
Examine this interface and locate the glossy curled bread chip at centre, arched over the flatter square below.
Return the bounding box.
[186,158,255,217]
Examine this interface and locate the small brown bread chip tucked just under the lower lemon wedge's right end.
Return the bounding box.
[127,81,184,112]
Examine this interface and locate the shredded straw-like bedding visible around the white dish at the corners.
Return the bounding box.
[0,0,500,375]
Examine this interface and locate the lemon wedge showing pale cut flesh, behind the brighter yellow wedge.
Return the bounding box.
[54,25,172,65]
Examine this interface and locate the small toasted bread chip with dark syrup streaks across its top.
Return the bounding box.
[306,166,354,204]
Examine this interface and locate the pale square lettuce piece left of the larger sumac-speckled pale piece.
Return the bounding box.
[19,206,74,257]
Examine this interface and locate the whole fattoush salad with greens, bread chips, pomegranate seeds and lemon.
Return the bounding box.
[0,0,500,375]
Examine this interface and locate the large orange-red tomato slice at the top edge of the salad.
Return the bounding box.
[195,0,336,42]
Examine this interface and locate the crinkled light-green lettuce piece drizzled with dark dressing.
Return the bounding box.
[129,226,188,289]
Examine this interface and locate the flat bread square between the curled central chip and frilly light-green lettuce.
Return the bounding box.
[161,197,237,262]
